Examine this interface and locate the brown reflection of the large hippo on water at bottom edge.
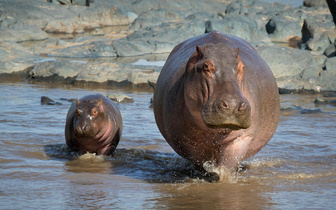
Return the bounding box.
[151,183,272,209]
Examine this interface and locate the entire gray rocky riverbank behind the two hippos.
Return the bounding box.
[0,0,336,92]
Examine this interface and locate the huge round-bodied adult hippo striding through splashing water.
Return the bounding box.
[154,31,280,176]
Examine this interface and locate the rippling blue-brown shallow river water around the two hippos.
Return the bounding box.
[0,83,336,209]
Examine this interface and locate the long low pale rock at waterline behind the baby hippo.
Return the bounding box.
[29,61,161,88]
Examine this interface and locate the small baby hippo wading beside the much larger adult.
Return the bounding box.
[65,94,123,155]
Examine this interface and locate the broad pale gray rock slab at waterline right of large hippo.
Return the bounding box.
[257,46,336,92]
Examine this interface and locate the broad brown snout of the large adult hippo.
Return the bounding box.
[202,95,251,130]
